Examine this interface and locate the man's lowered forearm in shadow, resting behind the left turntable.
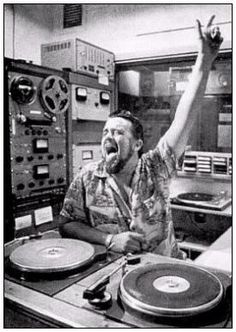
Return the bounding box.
[59,221,108,245]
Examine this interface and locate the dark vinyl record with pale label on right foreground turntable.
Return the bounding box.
[119,263,224,318]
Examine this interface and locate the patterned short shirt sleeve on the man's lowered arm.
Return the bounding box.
[60,171,87,222]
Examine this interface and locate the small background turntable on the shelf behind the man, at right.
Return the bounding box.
[172,191,231,211]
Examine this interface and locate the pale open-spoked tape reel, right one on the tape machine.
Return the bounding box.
[40,75,70,114]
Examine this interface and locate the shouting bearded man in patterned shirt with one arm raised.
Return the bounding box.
[60,16,223,258]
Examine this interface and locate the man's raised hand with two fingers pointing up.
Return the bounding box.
[197,15,223,61]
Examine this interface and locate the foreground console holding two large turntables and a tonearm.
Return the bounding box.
[5,238,231,327]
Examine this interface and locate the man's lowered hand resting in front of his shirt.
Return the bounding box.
[111,232,145,253]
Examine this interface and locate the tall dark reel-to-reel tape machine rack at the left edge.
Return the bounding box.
[4,59,71,240]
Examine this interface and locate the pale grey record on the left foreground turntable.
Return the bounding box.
[9,239,95,273]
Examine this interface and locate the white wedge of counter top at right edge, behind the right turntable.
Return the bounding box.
[194,227,232,274]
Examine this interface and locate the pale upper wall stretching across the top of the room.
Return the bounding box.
[5,4,231,64]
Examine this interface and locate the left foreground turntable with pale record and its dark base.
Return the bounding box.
[5,235,121,296]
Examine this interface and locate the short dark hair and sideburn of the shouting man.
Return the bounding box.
[109,110,144,157]
